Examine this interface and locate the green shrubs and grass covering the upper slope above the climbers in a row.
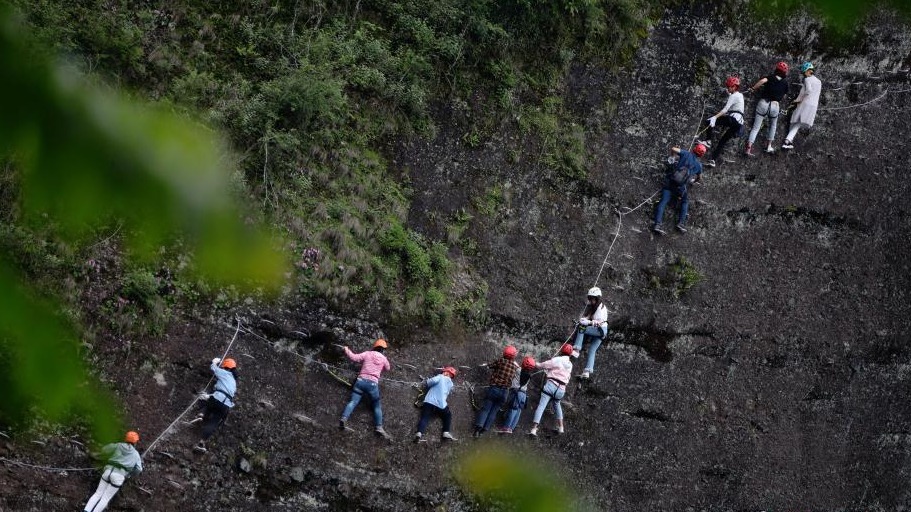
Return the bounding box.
[5,0,655,328]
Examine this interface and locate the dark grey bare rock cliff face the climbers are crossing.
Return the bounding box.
[0,5,911,511]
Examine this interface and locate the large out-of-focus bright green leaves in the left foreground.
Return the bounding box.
[0,4,283,439]
